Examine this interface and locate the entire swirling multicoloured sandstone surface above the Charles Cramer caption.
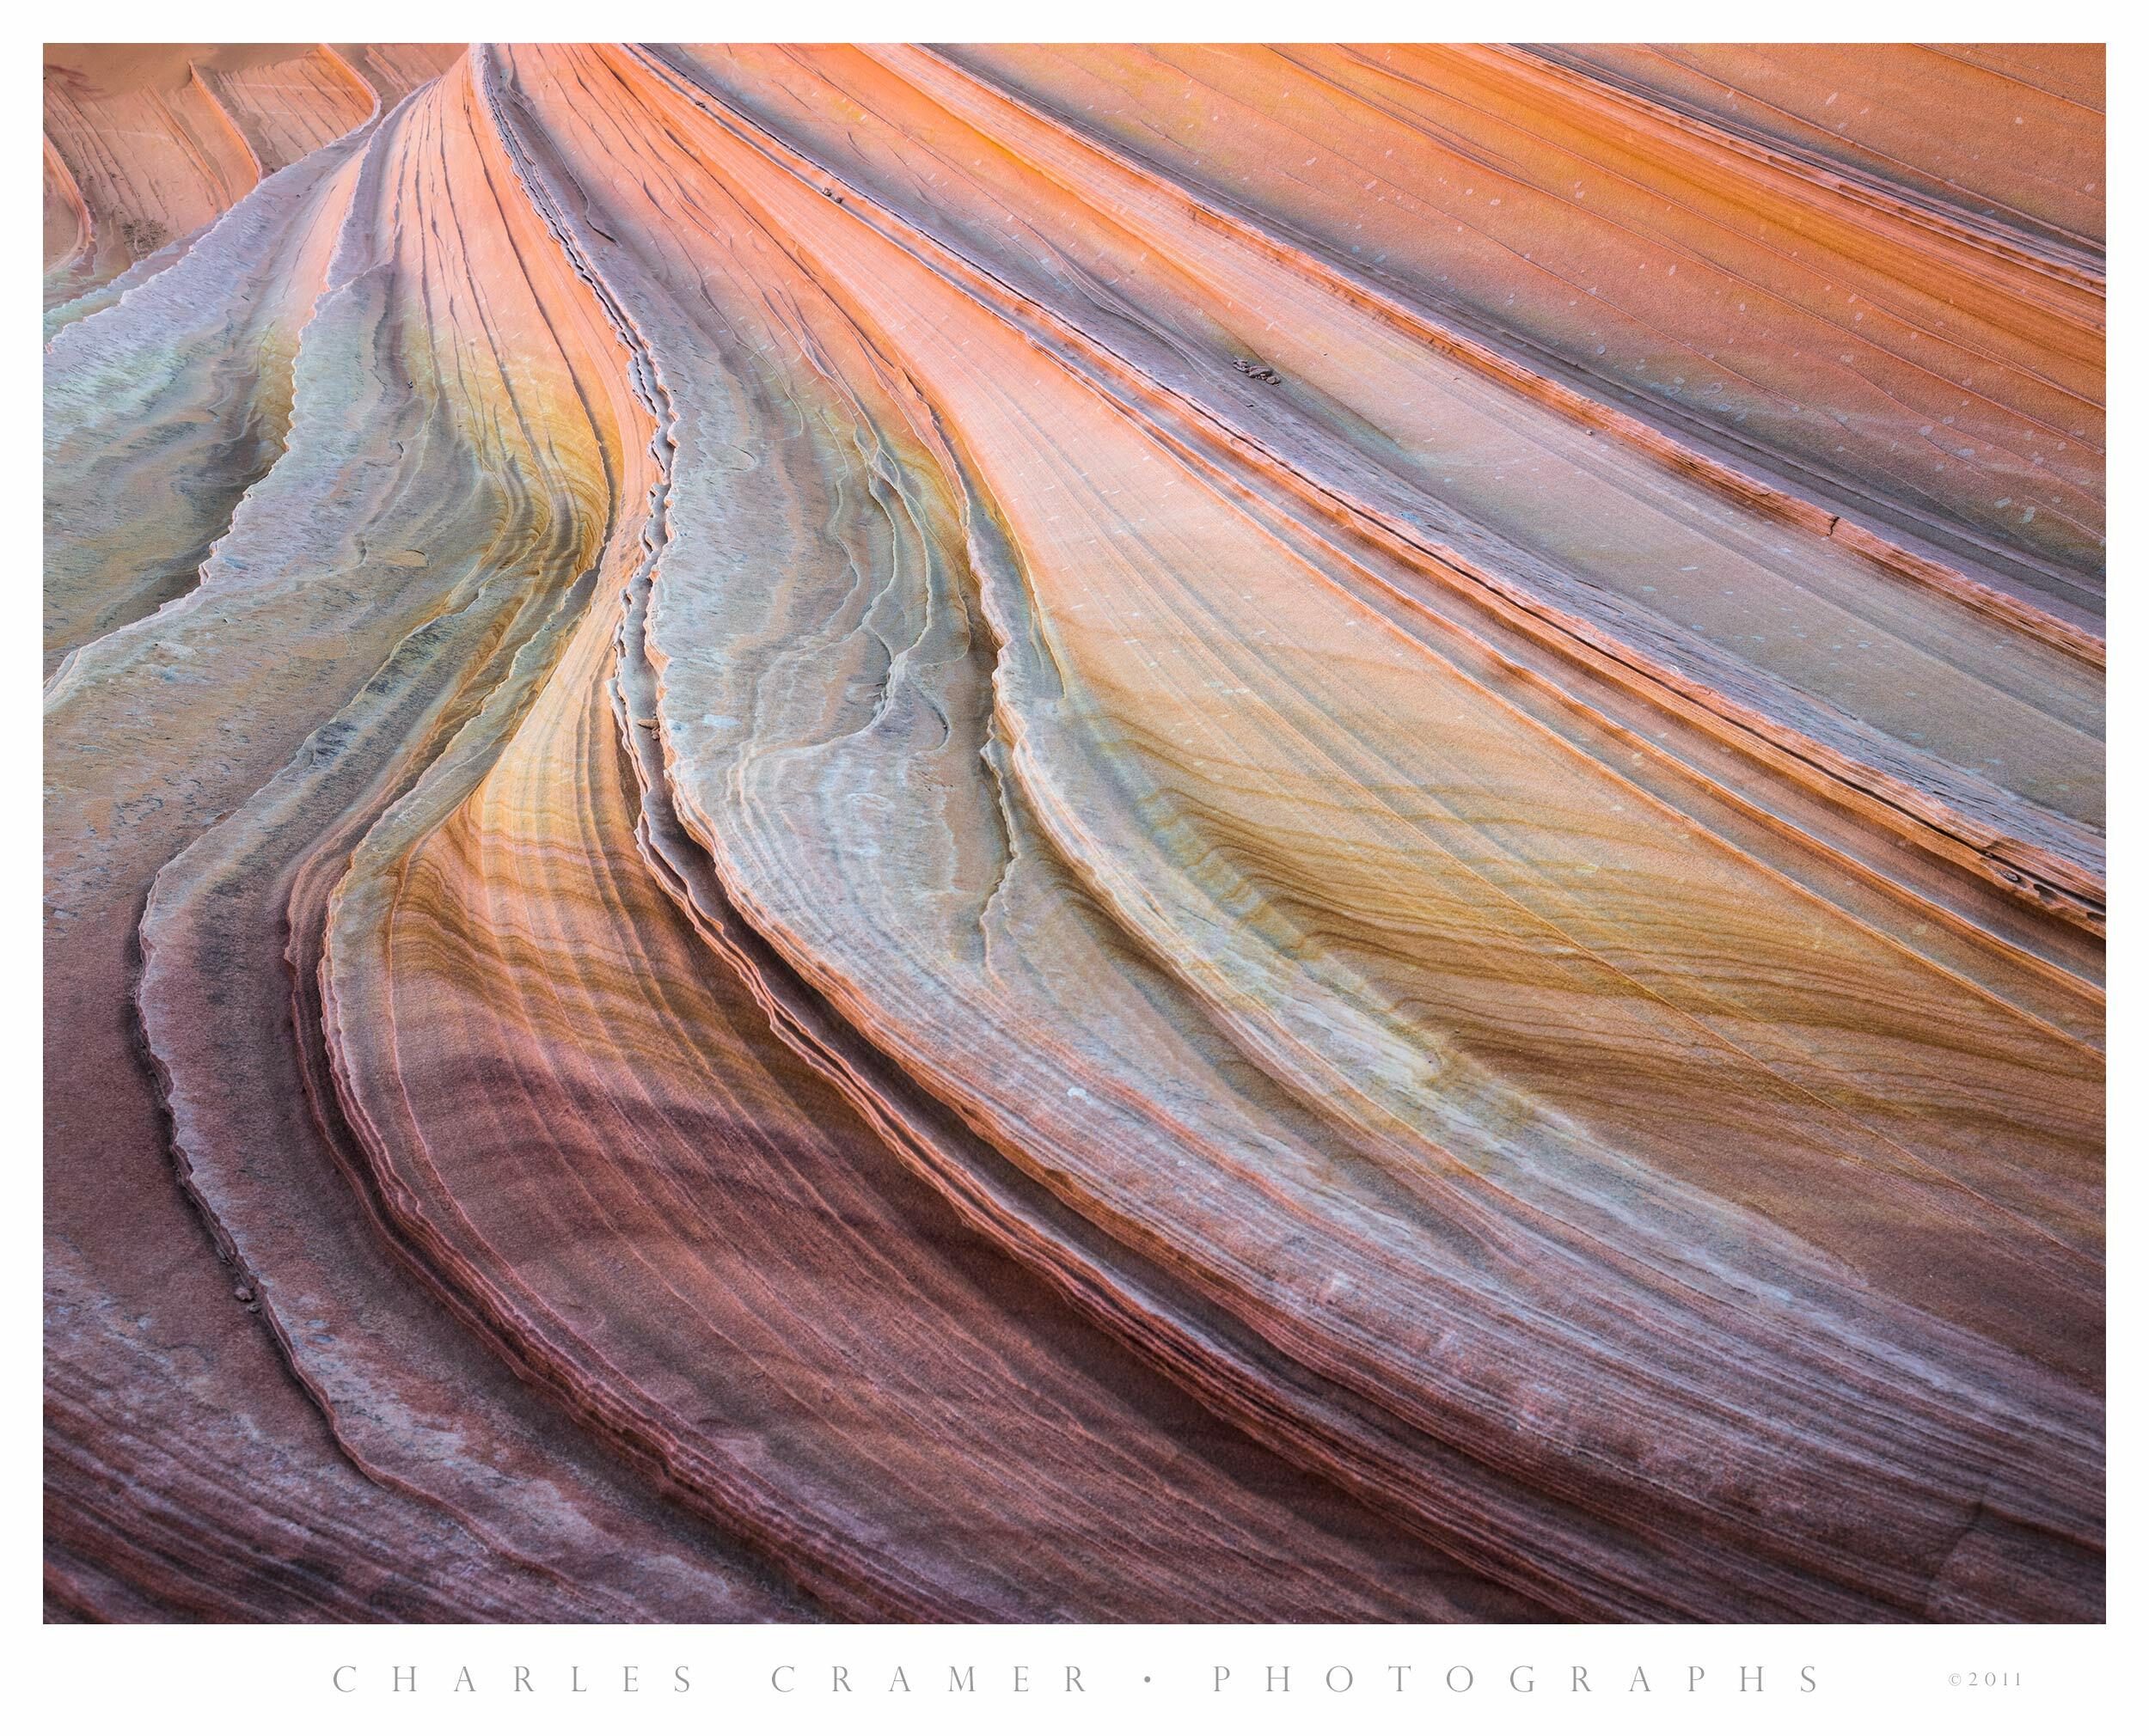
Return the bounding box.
[46,46,2104,1620]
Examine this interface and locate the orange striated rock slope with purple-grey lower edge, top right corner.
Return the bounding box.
[958,46,2104,617]
